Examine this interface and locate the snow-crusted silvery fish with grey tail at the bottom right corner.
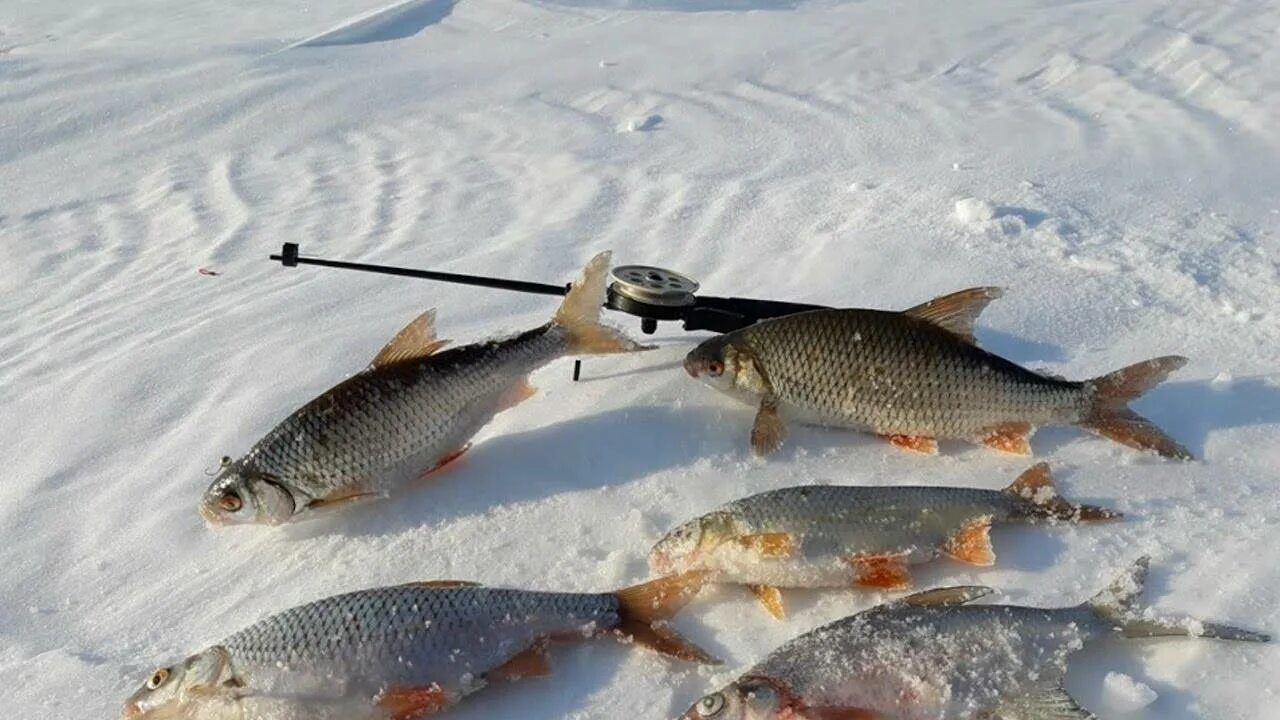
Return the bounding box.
[682,557,1271,720]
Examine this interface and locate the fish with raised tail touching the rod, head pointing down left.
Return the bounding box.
[198,252,652,527]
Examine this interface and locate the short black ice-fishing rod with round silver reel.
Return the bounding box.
[271,242,823,333]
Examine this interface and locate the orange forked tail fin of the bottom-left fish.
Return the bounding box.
[614,573,719,665]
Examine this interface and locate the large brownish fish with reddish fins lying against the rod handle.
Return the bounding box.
[684,287,1193,460]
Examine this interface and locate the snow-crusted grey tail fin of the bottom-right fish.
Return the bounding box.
[1087,557,1271,642]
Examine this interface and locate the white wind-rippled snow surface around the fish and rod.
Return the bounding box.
[0,0,1280,720]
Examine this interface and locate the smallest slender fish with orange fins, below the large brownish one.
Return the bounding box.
[649,462,1121,619]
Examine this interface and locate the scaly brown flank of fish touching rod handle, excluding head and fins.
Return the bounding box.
[741,310,1089,438]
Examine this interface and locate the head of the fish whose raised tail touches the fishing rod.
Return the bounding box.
[200,457,296,527]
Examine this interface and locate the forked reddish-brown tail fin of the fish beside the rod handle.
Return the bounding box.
[1079,355,1196,460]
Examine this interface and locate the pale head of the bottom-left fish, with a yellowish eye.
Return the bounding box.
[120,647,241,720]
